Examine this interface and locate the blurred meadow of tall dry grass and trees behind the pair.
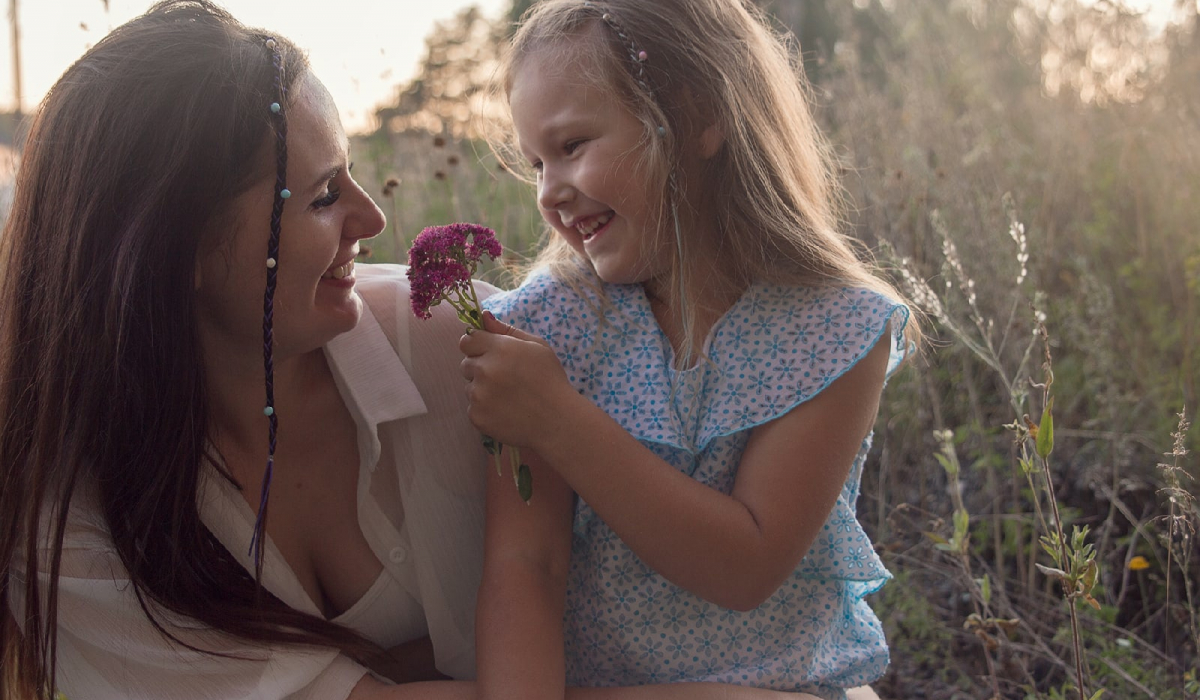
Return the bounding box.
[0,0,1200,700]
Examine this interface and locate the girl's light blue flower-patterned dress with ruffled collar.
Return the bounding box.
[484,271,908,699]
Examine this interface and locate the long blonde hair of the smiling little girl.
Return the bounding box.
[493,0,919,359]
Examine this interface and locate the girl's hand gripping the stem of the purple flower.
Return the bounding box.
[458,311,582,449]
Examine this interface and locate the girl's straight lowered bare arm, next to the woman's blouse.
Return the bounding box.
[475,449,574,700]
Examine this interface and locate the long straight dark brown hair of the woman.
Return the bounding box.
[0,0,377,698]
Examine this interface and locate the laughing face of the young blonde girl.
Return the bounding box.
[509,40,671,285]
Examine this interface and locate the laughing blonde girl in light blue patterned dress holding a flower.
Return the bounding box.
[460,0,917,699]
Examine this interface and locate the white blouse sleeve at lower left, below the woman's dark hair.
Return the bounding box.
[10,508,367,700]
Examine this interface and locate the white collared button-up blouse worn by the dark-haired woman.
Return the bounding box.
[10,264,494,700]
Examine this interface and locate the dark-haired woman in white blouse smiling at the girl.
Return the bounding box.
[0,0,816,700]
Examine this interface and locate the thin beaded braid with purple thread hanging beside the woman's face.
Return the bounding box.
[250,40,288,569]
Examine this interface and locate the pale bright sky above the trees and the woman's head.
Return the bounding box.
[0,0,509,132]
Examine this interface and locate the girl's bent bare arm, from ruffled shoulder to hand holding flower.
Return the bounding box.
[461,318,889,610]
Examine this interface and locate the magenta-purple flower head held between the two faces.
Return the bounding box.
[408,223,503,325]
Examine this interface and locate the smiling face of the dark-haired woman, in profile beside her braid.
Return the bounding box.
[196,73,385,357]
